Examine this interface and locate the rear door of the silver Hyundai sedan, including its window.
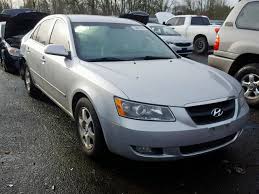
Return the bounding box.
[25,19,54,89]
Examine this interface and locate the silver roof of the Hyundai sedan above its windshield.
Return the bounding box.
[67,15,141,25]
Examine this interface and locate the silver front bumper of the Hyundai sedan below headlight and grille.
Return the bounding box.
[100,100,249,161]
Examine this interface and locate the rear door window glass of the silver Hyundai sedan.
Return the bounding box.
[36,20,53,45]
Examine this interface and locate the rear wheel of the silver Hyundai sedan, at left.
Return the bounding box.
[24,65,40,98]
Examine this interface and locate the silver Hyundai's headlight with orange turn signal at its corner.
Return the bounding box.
[114,97,175,121]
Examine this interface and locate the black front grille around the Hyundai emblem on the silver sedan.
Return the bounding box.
[186,99,235,125]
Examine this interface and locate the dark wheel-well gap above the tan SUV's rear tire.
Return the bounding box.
[228,53,259,76]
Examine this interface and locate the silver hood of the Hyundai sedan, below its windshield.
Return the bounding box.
[85,59,241,107]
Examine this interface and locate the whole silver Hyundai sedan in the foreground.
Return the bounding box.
[22,15,249,161]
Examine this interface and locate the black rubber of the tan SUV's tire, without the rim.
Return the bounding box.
[235,63,259,107]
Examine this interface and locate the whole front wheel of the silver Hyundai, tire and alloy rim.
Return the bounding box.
[75,98,107,158]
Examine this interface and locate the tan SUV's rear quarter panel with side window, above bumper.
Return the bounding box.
[219,1,259,56]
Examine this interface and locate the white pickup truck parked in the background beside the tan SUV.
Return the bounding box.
[165,15,220,54]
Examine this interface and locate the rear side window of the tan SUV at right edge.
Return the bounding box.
[236,2,259,30]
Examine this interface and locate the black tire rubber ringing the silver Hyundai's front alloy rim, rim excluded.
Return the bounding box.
[75,98,106,158]
